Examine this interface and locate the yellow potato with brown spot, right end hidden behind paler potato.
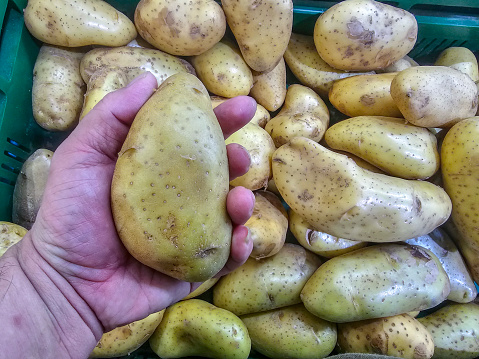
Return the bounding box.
[329,72,402,117]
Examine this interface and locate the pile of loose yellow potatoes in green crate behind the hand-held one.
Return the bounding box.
[11,0,479,359]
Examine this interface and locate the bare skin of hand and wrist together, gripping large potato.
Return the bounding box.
[0,73,256,358]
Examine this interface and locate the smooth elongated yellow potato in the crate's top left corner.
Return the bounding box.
[23,0,137,47]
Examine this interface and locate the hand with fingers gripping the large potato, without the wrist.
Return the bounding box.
[24,74,256,338]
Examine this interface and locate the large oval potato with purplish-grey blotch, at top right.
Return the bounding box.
[314,0,418,71]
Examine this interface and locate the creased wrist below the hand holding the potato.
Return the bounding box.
[0,232,103,358]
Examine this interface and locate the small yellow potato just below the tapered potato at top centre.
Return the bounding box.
[250,58,286,112]
